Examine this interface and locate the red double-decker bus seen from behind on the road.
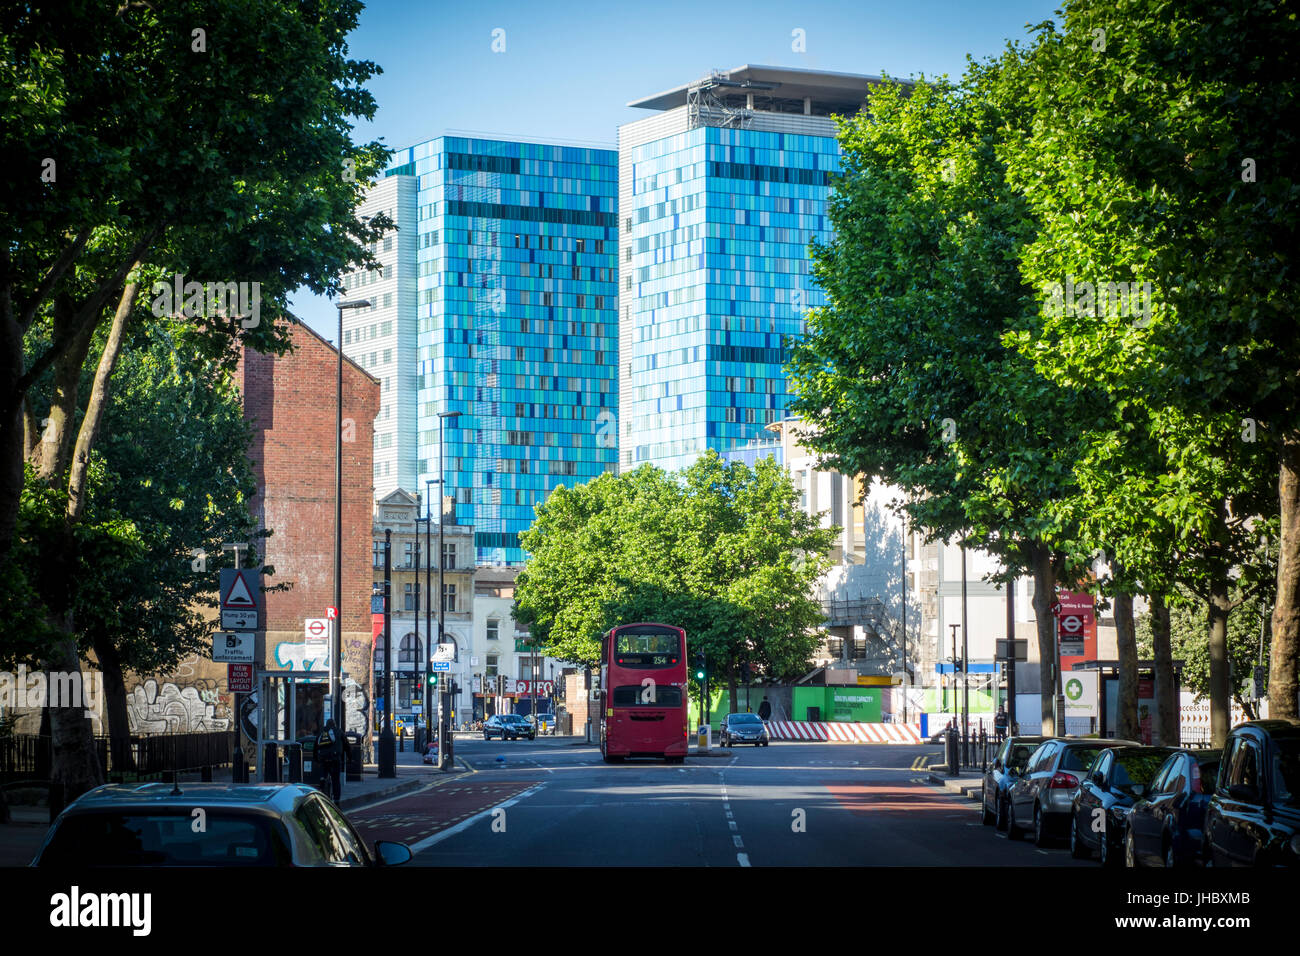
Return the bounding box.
[601,623,690,763]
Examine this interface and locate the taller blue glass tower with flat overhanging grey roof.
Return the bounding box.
[619,66,880,468]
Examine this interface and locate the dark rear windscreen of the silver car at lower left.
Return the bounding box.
[40,809,293,866]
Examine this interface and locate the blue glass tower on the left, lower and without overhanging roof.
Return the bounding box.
[387,137,618,564]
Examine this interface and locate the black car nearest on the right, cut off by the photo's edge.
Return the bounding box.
[1204,719,1300,866]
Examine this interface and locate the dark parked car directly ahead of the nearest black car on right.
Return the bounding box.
[1125,750,1223,868]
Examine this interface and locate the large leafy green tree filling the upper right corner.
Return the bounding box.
[1002,0,1300,743]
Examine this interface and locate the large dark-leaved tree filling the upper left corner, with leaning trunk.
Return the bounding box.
[0,0,391,797]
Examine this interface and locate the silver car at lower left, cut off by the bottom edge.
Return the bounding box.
[33,783,411,869]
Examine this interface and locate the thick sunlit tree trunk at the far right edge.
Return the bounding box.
[1269,429,1300,719]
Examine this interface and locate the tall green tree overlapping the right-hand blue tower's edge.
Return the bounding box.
[789,70,1091,728]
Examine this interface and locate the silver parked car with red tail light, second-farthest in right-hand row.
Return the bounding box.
[1006,737,1140,847]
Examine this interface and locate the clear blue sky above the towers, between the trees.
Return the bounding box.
[291,0,1058,341]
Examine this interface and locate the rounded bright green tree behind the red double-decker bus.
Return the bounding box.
[515,451,835,706]
